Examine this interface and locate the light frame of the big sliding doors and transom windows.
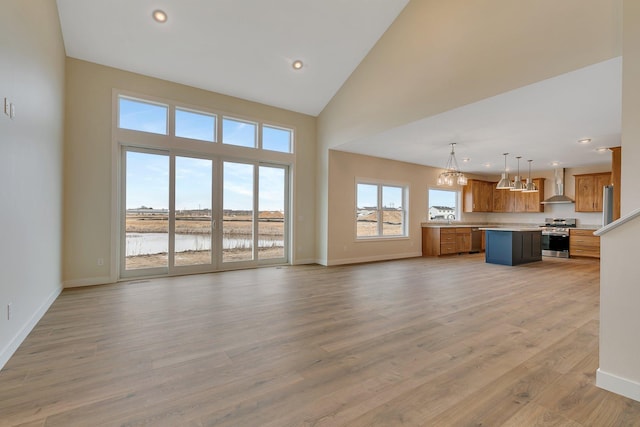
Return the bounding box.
[110,88,297,281]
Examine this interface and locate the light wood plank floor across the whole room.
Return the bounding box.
[0,255,640,427]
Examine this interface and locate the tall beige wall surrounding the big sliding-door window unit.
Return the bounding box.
[63,58,316,286]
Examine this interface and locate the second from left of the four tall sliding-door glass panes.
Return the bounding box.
[174,157,213,265]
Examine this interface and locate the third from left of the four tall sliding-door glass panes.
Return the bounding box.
[222,162,253,262]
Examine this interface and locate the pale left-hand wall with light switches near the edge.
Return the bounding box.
[0,0,65,367]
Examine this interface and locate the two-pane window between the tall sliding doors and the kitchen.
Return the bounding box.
[356,182,408,239]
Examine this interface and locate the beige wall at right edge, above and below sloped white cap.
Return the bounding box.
[597,0,640,401]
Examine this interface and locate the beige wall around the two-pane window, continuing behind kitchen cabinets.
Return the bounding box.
[322,150,611,265]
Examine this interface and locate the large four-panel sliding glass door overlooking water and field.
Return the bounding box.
[120,147,288,277]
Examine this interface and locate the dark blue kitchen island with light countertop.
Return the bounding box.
[481,227,542,265]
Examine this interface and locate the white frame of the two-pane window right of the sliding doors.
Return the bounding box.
[354,179,409,242]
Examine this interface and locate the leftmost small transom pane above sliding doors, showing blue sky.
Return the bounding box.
[118,97,168,135]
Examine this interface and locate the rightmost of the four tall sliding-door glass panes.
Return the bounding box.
[258,166,286,259]
